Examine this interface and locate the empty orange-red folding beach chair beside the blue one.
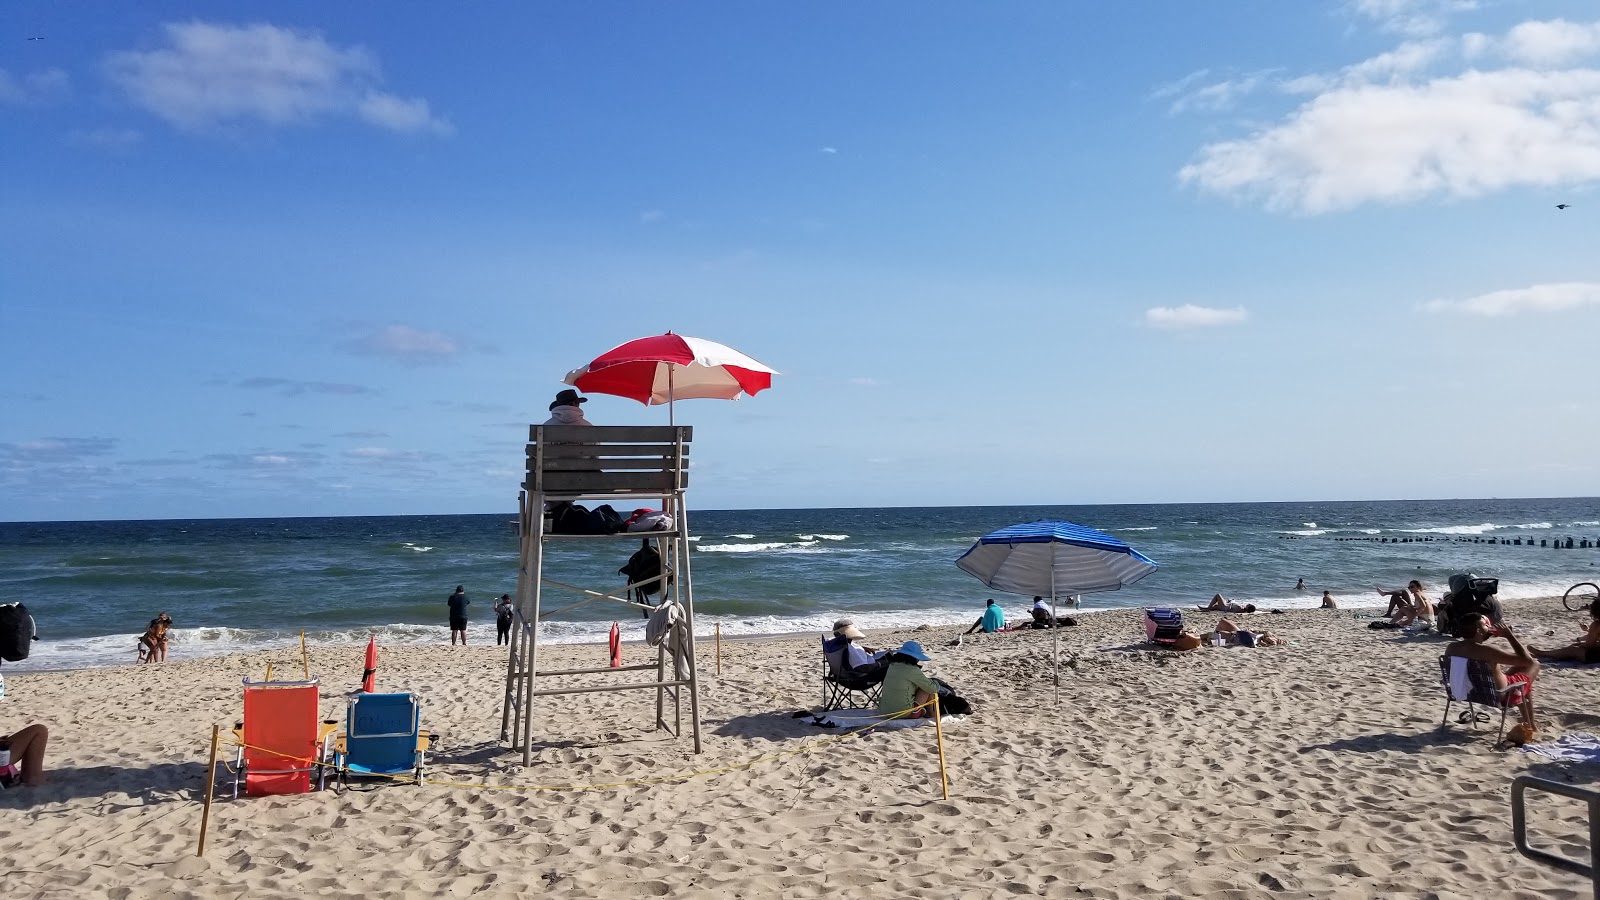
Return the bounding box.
[234,679,338,799]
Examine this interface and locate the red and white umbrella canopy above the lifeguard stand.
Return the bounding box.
[563,331,778,405]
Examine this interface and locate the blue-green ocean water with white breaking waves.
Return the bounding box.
[0,498,1600,671]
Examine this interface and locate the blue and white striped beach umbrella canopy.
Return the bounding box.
[955,522,1155,597]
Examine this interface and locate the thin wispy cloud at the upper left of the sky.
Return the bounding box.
[106,22,450,133]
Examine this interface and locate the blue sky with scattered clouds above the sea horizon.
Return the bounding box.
[0,0,1600,520]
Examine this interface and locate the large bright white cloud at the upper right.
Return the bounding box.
[1179,21,1600,215]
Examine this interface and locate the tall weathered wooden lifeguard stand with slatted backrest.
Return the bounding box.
[501,424,701,765]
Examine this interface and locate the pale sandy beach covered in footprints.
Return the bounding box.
[0,601,1600,898]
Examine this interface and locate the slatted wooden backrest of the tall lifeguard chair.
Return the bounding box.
[522,424,694,496]
